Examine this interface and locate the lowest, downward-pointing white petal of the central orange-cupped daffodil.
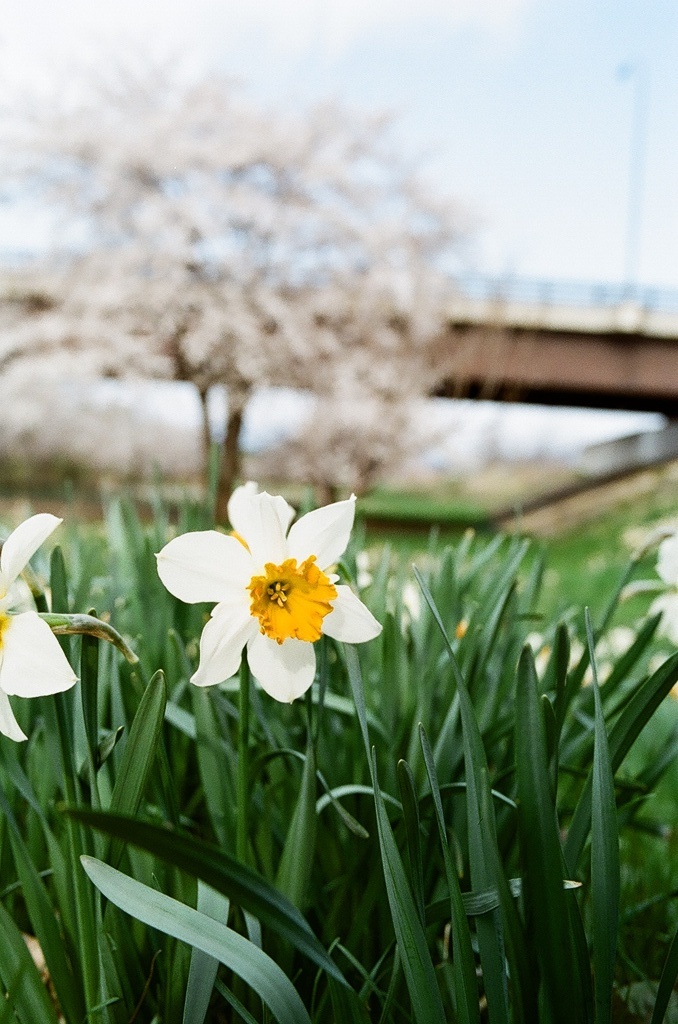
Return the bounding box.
[247,633,315,703]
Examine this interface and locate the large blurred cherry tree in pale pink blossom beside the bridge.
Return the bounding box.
[0,71,461,515]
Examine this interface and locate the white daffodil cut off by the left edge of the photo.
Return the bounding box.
[0,512,77,740]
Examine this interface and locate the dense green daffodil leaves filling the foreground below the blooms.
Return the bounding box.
[0,491,678,1024]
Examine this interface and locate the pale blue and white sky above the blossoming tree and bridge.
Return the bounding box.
[0,0,678,289]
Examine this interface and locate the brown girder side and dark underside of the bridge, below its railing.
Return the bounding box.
[435,325,678,418]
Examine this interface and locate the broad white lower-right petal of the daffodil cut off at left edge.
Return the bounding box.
[0,611,78,697]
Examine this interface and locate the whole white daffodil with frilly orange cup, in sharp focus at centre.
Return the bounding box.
[157,483,381,702]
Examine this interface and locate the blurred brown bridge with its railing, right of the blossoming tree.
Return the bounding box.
[437,279,678,418]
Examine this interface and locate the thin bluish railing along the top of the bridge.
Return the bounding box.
[455,274,678,313]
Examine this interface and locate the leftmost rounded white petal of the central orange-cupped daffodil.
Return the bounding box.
[156,529,253,604]
